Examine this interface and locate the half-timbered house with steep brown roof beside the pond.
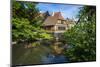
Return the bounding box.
[43,12,74,37]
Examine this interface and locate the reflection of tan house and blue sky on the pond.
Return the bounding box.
[41,41,68,64]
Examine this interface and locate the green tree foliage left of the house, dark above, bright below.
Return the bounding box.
[12,0,51,42]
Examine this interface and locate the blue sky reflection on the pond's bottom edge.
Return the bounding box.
[42,54,68,64]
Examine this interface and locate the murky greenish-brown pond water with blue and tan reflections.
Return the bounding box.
[12,42,69,65]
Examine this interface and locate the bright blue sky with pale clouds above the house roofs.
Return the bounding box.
[36,3,82,19]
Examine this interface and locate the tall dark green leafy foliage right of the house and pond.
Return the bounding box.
[64,6,96,62]
